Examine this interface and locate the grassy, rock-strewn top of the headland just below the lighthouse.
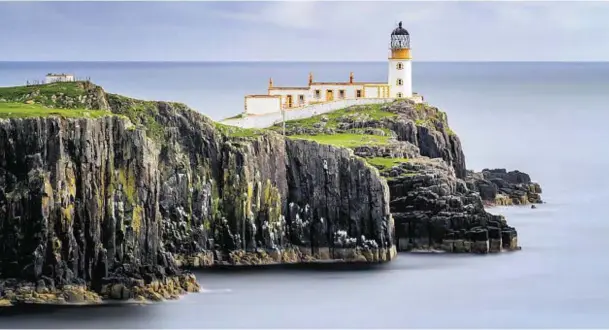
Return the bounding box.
[270,100,460,174]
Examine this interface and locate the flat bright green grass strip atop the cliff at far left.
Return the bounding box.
[0,102,112,118]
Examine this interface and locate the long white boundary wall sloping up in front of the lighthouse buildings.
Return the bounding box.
[221,98,395,128]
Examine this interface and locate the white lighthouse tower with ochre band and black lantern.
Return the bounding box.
[388,22,412,98]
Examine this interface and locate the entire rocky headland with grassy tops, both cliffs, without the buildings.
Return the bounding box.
[0,83,541,306]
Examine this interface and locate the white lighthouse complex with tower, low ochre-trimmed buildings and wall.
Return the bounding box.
[245,22,423,115]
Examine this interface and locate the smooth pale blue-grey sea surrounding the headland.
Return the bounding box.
[0,62,609,329]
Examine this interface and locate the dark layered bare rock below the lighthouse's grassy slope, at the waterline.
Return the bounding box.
[382,158,520,254]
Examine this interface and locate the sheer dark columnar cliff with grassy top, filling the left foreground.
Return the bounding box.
[0,83,395,305]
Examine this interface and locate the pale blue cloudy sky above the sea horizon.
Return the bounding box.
[0,1,609,61]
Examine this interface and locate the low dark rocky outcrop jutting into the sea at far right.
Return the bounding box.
[466,169,543,205]
